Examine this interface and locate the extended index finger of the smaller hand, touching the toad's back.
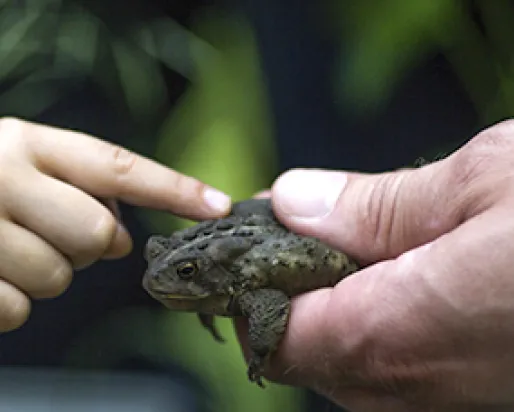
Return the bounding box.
[12,119,231,219]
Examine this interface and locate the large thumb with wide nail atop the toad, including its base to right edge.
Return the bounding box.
[272,121,514,262]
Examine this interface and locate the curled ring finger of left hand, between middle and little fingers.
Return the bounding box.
[0,220,73,299]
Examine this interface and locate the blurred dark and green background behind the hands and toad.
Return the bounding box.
[0,0,514,412]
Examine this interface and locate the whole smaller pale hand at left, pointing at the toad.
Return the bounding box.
[0,118,230,331]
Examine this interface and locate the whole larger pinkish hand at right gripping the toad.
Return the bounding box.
[237,121,514,412]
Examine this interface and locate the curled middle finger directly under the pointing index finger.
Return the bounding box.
[4,169,128,269]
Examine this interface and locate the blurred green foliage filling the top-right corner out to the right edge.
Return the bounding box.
[329,0,514,123]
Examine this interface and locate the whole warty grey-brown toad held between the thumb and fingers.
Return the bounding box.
[143,199,358,386]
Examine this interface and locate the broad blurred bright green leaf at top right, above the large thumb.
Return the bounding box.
[330,0,456,111]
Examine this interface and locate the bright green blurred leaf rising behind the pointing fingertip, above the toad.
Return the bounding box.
[145,12,276,228]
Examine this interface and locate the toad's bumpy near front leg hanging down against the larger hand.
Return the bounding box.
[238,289,290,387]
